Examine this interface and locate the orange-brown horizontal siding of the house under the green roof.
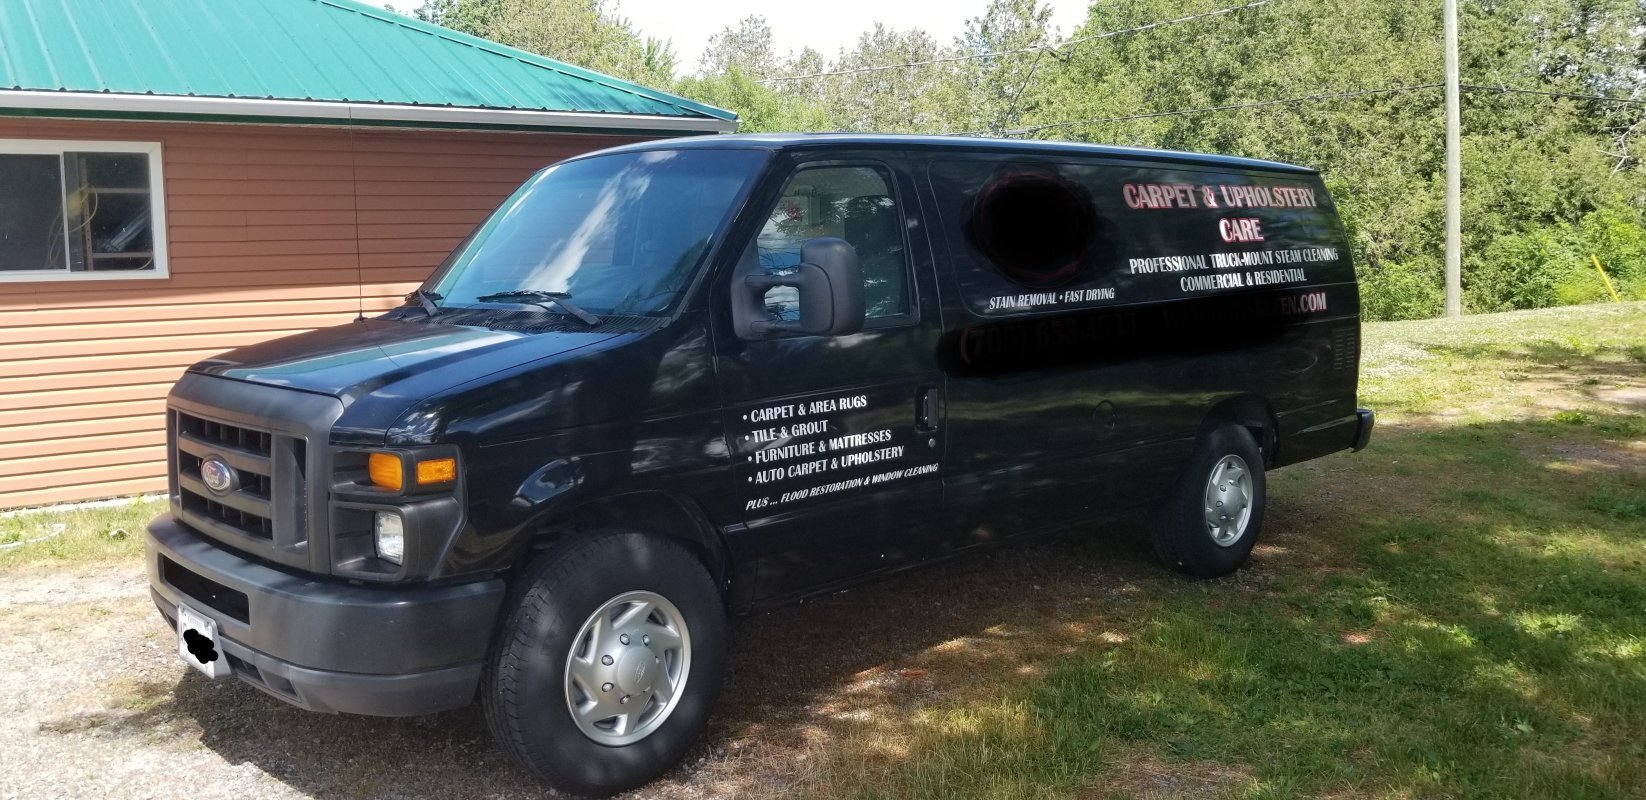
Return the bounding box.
[0,119,629,507]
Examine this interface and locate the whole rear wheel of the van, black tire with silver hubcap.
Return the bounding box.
[1152,425,1266,578]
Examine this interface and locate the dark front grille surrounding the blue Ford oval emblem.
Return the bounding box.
[173,410,308,547]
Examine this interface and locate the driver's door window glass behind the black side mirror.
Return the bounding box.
[756,166,909,326]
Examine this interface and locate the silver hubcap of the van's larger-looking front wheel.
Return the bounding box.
[566,591,691,746]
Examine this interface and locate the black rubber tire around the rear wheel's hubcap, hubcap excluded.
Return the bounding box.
[1152,425,1267,578]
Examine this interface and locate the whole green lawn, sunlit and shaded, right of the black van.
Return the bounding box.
[807,303,1646,798]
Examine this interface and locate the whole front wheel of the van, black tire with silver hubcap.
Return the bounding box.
[482,532,726,795]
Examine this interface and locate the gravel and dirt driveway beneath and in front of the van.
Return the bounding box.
[0,520,1198,800]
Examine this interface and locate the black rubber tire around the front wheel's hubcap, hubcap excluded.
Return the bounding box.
[481,532,726,797]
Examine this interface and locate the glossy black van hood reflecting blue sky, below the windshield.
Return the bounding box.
[189,319,617,405]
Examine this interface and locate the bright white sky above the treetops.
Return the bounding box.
[367,0,1090,74]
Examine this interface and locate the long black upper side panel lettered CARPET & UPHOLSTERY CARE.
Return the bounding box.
[927,156,1353,318]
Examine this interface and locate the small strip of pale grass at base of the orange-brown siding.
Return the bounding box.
[0,499,166,571]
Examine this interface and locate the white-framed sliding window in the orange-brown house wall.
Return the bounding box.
[0,140,166,281]
